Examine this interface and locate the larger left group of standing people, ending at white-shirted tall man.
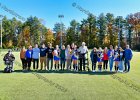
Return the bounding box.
[20,42,88,71]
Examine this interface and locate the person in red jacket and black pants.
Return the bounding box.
[103,47,109,71]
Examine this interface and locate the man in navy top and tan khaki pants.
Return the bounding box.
[40,44,47,70]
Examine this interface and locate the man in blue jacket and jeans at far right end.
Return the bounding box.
[124,45,133,72]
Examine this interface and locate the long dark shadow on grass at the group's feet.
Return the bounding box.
[0,70,116,75]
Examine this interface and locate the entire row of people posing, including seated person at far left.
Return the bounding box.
[4,42,133,72]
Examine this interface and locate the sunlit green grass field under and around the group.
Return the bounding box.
[0,51,140,100]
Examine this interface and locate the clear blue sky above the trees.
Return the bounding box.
[0,0,140,29]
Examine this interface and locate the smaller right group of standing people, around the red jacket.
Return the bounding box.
[90,45,133,72]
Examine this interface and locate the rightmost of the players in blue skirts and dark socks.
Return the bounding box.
[114,46,119,72]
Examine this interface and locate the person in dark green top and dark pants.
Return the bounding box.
[60,45,66,70]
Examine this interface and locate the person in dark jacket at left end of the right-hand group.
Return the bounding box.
[90,48,98,72]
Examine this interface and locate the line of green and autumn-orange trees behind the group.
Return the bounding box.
[2,13,140,50]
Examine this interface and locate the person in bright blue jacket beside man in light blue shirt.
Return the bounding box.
[25,46,33,70]
